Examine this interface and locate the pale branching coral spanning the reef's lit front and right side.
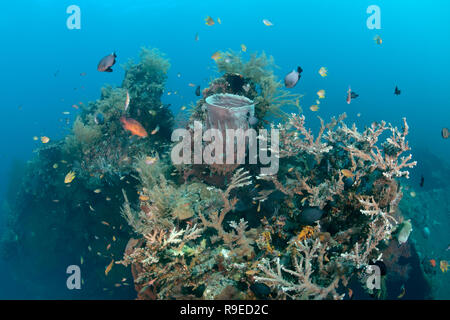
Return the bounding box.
[123,108,415,299]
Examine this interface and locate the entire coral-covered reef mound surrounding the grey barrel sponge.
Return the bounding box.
[4,48,424,299]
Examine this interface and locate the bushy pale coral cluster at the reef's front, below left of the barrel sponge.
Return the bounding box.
[120,166,260,299]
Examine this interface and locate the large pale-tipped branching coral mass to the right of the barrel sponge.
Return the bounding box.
[248,115,415,298]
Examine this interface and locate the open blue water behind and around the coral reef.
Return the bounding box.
[0,0,450,299]
